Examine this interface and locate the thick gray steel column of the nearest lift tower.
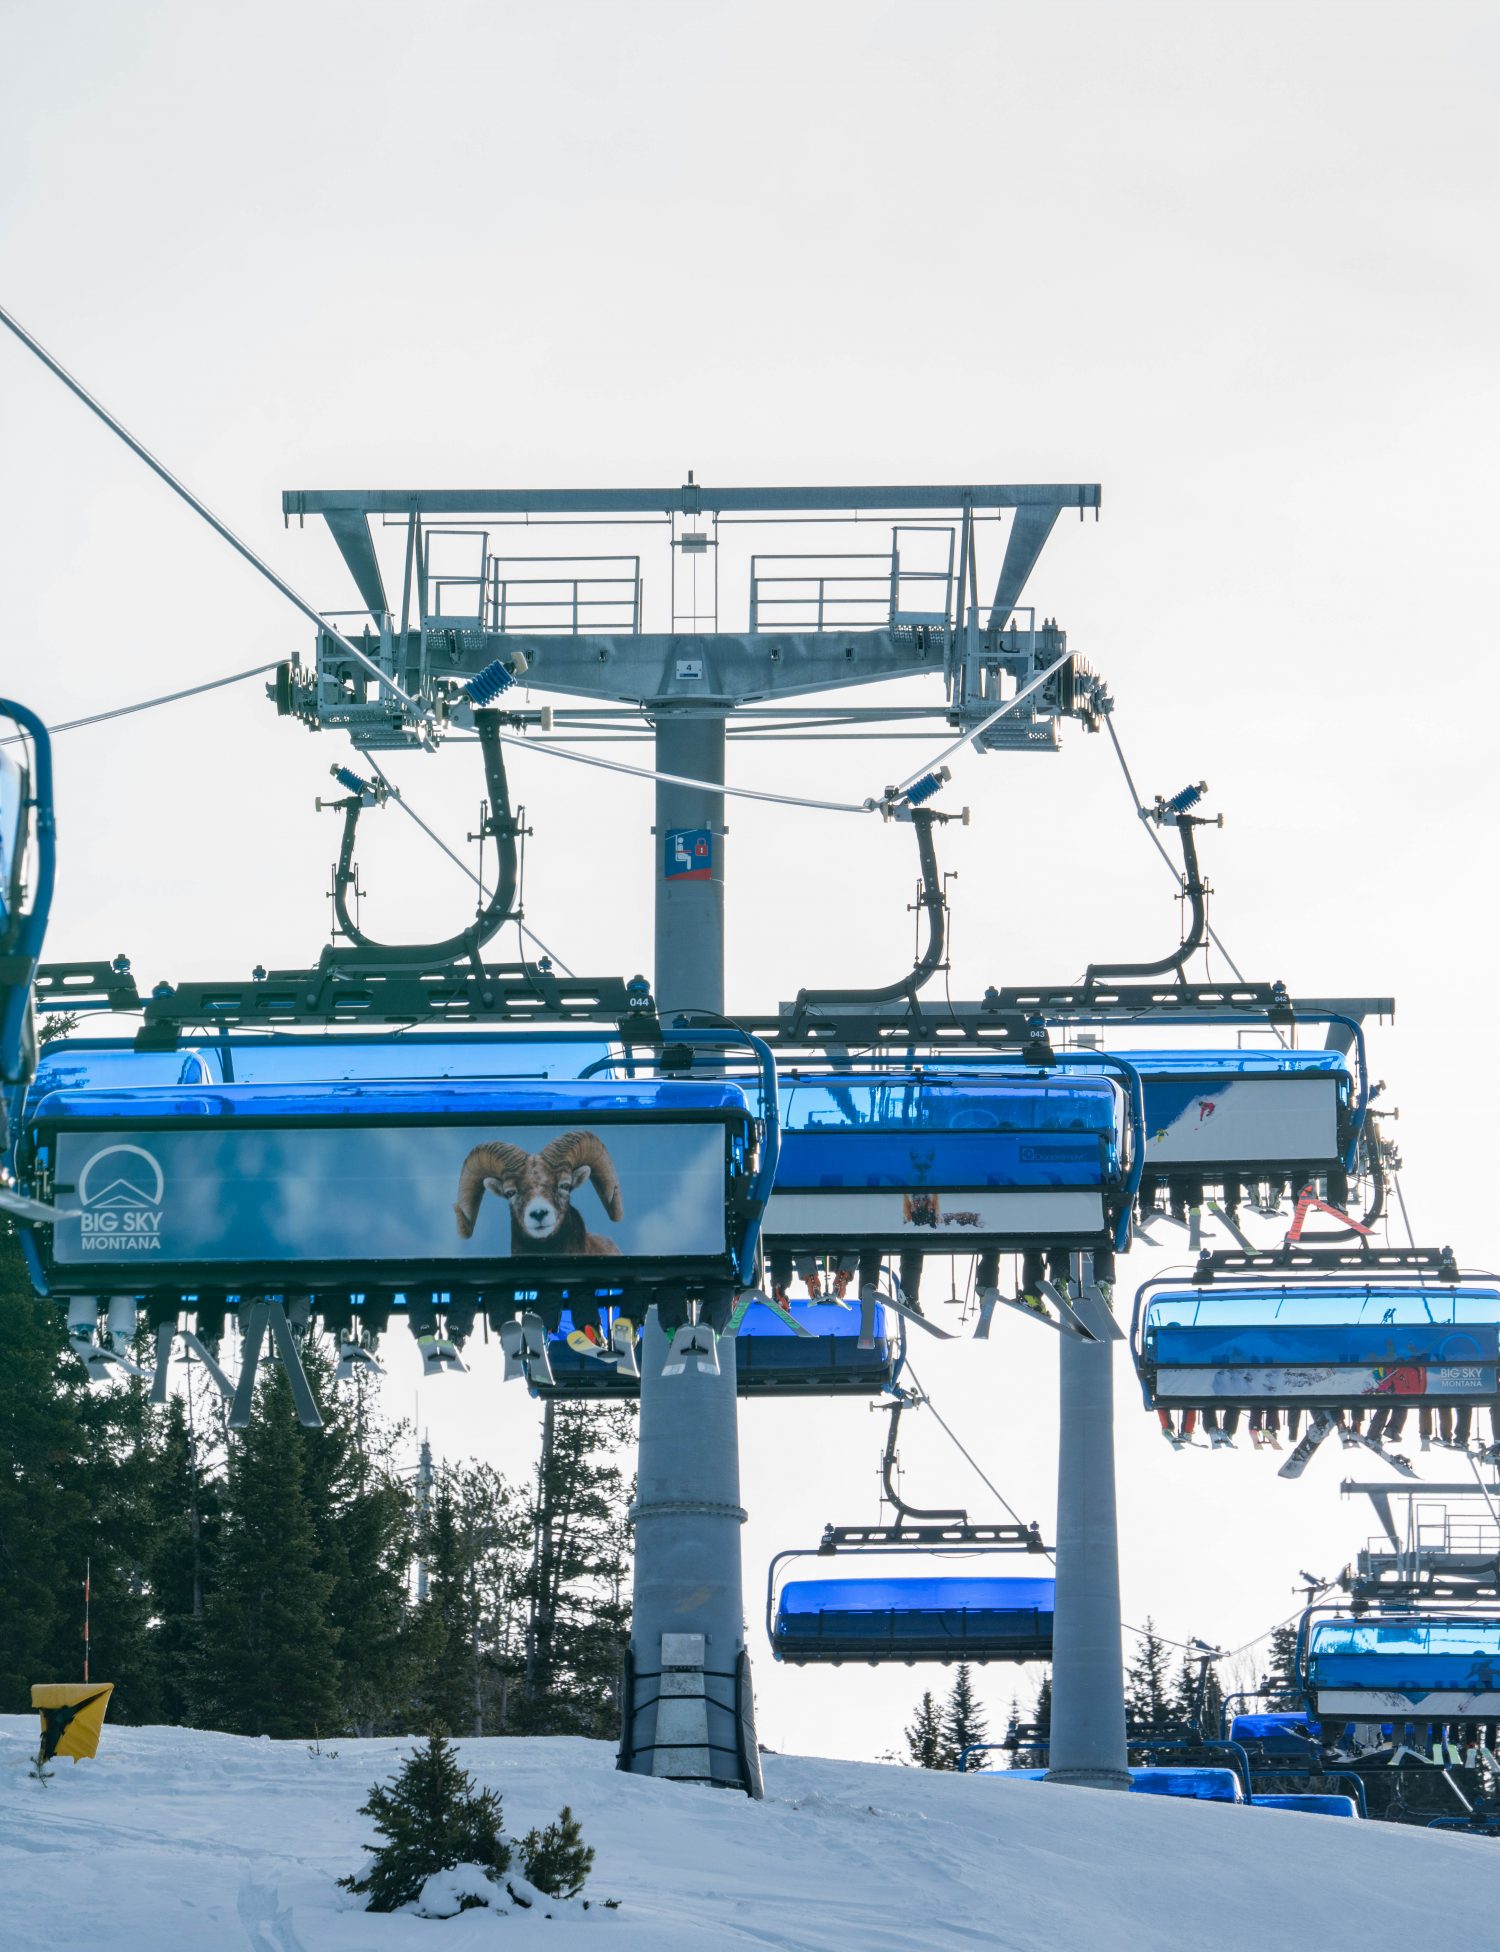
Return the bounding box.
[621,716,760,1796]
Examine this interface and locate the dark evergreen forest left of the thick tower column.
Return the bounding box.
[0,1230,635,1739]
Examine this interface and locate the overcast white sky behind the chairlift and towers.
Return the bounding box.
[0,0,1500,1755]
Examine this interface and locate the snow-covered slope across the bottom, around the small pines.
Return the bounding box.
[0,1716,1500,1952]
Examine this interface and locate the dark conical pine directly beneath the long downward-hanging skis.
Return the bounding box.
[203,1366,339,1737]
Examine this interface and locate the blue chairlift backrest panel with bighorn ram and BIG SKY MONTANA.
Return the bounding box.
[27,1077,756,1294]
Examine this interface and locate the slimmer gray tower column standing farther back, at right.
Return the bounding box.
[1047,1257,1131,1790]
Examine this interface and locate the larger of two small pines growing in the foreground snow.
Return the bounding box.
[338,1729,507,1911]
